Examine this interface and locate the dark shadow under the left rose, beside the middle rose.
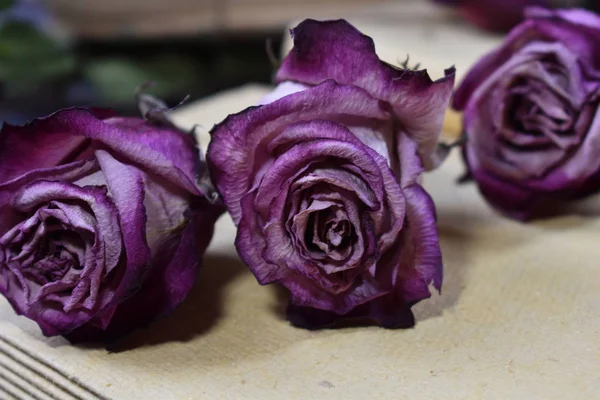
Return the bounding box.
[107,254,247,352]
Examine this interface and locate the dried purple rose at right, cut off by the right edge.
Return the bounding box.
[454,8,600,219]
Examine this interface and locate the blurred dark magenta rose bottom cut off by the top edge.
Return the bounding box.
[435,0,551,31]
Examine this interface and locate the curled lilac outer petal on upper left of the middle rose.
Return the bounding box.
[207,81,389,224]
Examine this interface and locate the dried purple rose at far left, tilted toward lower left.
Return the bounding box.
[0,109,219,341]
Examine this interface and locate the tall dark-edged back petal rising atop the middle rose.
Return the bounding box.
[277,19,454,169]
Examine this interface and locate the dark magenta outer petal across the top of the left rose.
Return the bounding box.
[0,109,203,193]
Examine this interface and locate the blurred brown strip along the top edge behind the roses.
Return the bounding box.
[46,0,391,38]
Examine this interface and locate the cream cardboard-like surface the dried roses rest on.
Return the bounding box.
[0,18,600,400]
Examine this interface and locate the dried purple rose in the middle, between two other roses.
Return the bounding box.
[208,20,454,328]
